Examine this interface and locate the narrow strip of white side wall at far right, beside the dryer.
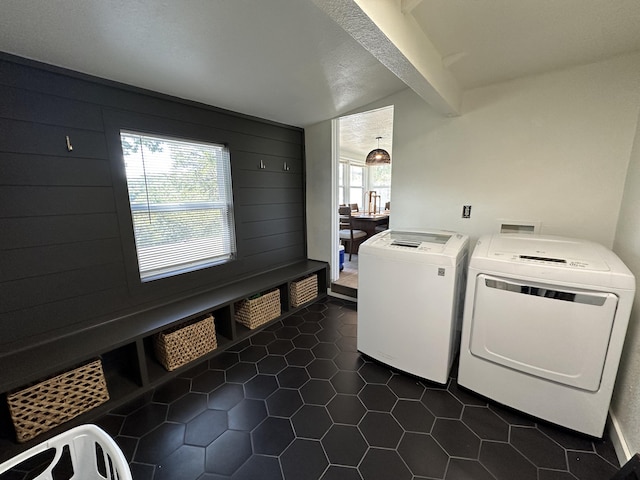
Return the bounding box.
[611,105,640,456]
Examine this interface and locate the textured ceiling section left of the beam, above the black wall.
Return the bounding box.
[0,0,406,126]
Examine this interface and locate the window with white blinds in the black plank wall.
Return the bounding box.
[120,130,236,282]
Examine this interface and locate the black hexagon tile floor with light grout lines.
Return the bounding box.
[90,298,618,480]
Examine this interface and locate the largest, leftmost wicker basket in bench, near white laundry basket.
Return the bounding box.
[7,359,109,442]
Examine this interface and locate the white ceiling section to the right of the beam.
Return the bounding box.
[411,0,640,89]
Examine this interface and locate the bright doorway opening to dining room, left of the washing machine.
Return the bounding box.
[331,105,393,299]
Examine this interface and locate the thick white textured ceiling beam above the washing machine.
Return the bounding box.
[313,0,460,116]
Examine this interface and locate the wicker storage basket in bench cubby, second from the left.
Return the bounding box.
[153,315,218,372]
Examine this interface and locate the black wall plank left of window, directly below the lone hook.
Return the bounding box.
[0,152,111,187]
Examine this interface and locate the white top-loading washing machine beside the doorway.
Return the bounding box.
[358,230,469,384]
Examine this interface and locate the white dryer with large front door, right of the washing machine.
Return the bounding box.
[458,234,635,437]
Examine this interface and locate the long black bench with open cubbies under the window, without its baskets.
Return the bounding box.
[0,260,328,456]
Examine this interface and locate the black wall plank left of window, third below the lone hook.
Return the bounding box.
[0,216,119,249]
